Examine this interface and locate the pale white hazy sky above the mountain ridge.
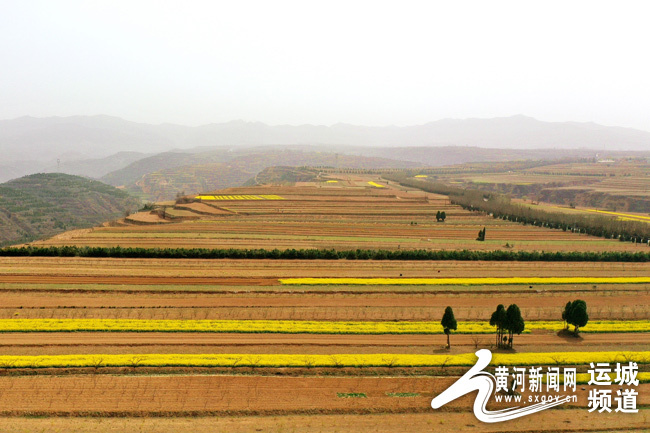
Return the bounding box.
[0,0,650,130]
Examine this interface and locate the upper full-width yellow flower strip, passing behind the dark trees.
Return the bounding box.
[0,319,650,334]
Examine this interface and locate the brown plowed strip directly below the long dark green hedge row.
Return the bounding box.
[0,257,650,276]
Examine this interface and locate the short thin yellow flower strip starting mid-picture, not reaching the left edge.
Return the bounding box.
[279,277,650,286]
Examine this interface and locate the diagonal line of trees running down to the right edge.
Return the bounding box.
[383,174,650,243]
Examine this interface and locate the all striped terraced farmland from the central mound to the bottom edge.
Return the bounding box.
[5,175,650,431]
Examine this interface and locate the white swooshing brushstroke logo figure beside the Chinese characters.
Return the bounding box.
[431,349,570,423]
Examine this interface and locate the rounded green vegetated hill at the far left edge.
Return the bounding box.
[0,173,140,246]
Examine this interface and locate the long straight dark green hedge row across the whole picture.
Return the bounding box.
[0,246,650,262]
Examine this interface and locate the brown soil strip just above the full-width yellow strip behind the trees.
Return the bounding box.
[0,289,650,321]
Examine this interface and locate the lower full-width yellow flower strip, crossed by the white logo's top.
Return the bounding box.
[0,352,650,368]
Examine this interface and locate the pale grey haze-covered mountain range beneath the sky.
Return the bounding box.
[0,115,650,184]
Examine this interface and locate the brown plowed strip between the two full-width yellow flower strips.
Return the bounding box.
[0,332,650,355]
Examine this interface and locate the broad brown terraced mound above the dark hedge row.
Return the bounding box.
[36,176,639,251]
